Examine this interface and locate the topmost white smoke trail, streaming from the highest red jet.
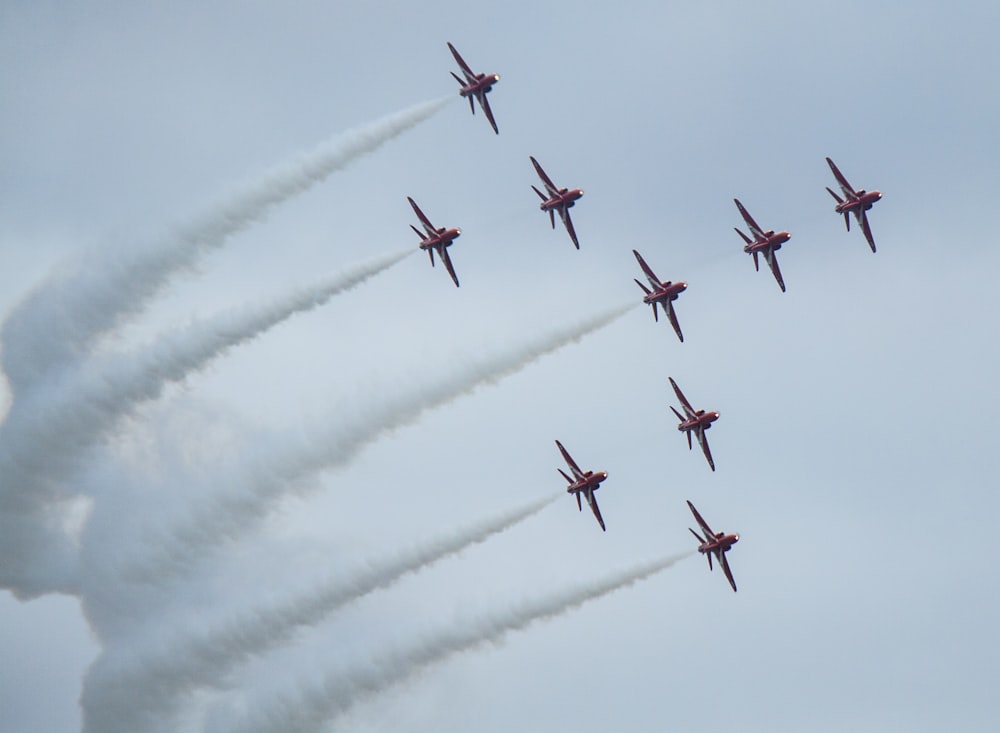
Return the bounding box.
[0,96,457,399]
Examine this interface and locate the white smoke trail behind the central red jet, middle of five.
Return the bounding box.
[123,302,636,583]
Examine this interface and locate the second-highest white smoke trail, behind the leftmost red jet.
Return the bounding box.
[0,249,417,594]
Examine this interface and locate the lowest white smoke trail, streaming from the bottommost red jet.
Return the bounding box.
[220,551,694,733]
